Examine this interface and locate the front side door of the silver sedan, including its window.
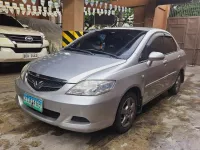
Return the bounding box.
[139,33,169,104]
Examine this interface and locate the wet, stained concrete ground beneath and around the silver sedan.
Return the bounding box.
[0,63,200,150]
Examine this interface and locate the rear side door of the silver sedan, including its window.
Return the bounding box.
[163,34,181,88]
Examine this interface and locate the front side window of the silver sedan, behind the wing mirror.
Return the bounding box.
[139,36,163,62]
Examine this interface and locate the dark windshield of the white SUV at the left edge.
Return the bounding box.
[0,14,23,28]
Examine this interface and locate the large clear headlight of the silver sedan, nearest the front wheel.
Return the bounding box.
[66,80,116,96]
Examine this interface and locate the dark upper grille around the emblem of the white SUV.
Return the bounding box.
[5,34,42,44]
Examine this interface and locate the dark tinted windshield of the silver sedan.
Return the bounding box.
[65,29,146,59]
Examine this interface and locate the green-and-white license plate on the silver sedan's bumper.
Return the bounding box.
[23,94,43,113]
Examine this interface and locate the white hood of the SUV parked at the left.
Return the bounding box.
[0,26,41,36]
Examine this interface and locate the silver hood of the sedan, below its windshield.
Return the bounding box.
[28,52,126,83]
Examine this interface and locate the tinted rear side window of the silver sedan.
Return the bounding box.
[163,36,177,54]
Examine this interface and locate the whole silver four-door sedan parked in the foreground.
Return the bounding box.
[16,28,186,133]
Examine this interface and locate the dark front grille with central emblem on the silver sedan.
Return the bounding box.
[27,72,67,92]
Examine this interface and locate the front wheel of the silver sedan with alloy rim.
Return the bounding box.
[114,92,137,133]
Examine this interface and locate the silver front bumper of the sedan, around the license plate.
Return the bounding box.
[16,78,118,133]
